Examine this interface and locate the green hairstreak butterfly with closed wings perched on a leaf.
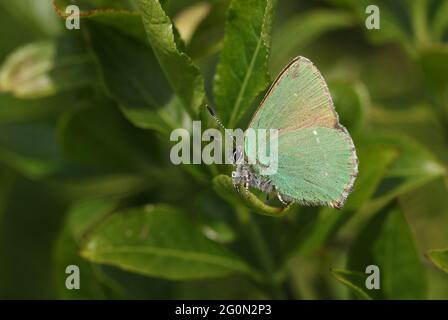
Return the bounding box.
[211,56,358,208]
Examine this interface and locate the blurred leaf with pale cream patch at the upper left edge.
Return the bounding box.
[0,36,97,98]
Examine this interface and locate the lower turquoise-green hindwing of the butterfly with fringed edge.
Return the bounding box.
[270,127,357,208]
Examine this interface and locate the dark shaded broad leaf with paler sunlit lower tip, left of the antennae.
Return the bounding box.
[85,23,188,137]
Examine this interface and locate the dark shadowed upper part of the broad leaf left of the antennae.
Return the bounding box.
[88,22,171,111]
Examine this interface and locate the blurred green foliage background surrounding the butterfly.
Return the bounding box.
[0,0,448,299]
